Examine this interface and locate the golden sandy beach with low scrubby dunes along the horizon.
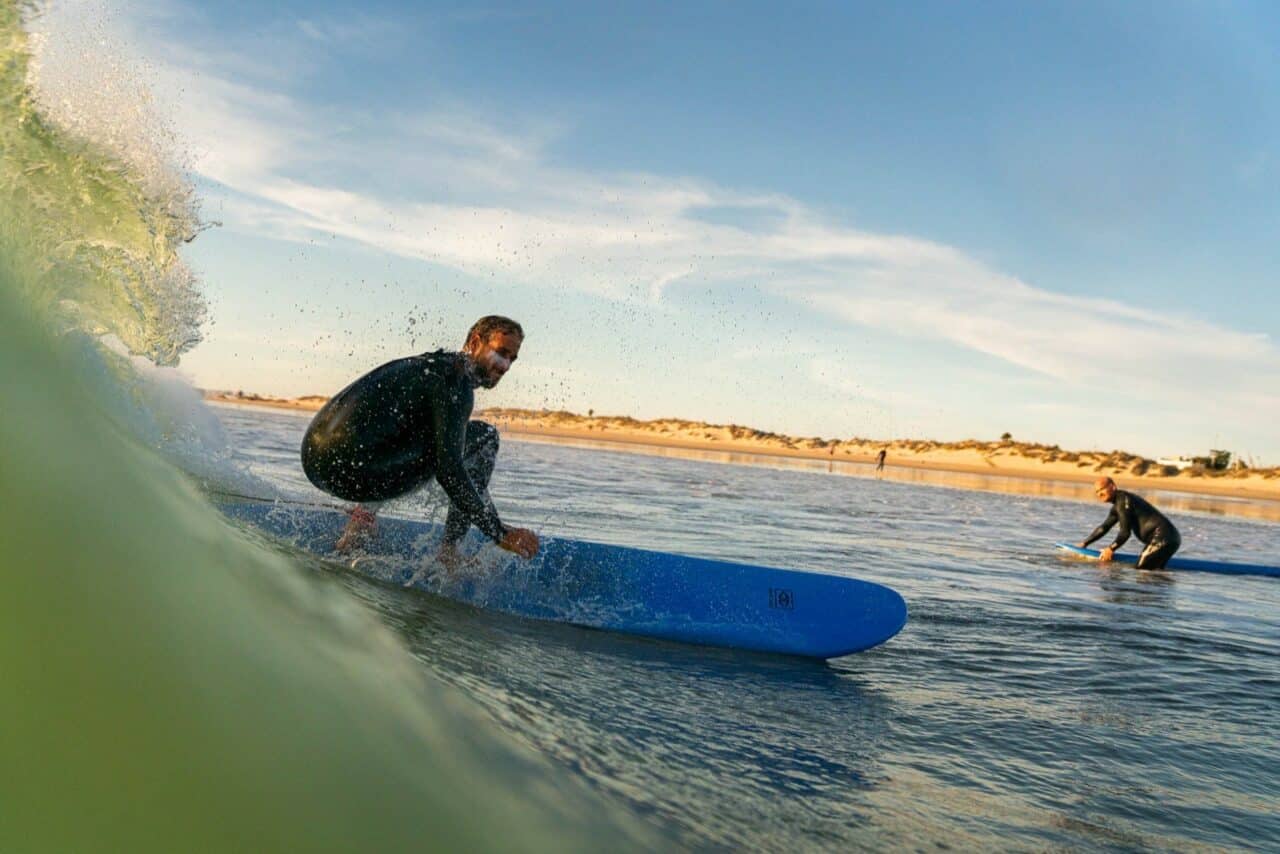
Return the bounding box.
[205,391,1280,501]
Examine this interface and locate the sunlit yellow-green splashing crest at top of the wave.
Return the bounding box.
[0,0,206,365]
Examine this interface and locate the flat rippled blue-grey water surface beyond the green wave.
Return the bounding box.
[209,407,1280,850]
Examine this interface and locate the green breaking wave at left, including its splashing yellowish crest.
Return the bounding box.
[0,0,652,851]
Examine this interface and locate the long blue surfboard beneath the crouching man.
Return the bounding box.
[220,502,906,658]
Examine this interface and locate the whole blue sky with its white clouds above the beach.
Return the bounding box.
[35,0,1280,463]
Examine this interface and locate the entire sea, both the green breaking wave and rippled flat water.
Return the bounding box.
[0,0,1280,851]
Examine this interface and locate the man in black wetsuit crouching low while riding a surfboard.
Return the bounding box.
[302,315,538,567]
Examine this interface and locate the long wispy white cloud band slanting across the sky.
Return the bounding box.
[80,5,1280,448]
